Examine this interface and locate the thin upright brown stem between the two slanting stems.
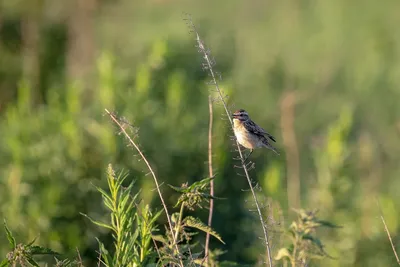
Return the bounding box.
[204,95,214,266]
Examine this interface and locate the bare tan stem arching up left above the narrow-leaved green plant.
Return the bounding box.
[105,109,183,267]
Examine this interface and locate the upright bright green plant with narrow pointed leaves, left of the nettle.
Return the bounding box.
[83,165,161,267]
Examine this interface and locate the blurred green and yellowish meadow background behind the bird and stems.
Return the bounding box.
[0,0,400,266]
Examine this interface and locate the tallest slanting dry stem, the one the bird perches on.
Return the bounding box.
[187,15,272,267]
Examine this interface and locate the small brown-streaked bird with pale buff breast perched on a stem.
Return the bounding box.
[232,109,280,161]
